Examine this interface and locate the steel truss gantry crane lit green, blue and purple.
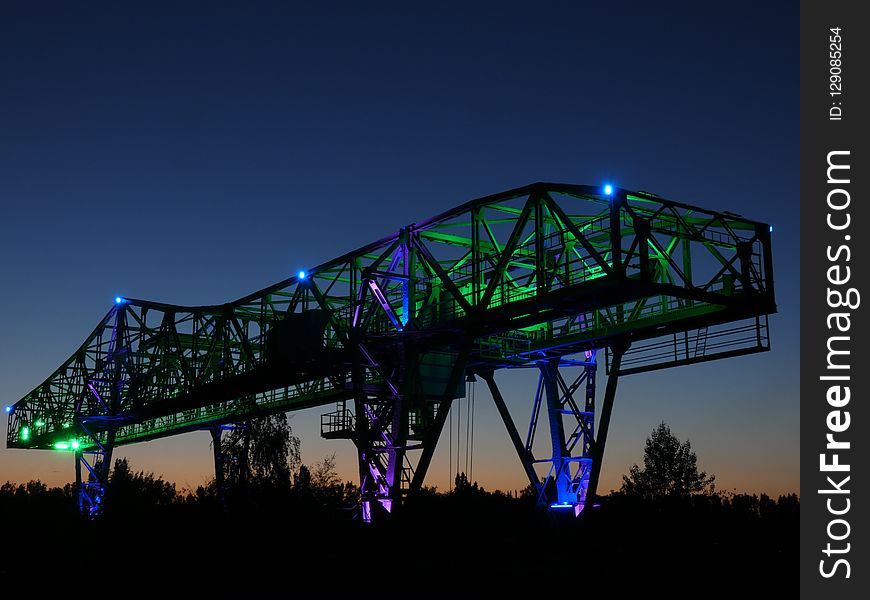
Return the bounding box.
[7,183,776,520]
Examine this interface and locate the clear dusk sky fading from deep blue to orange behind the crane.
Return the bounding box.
[0,2,799,494]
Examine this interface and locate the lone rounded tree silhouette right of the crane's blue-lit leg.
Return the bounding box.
[622,422,715,500]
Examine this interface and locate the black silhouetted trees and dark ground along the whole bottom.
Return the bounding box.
[0,420,800,600]
